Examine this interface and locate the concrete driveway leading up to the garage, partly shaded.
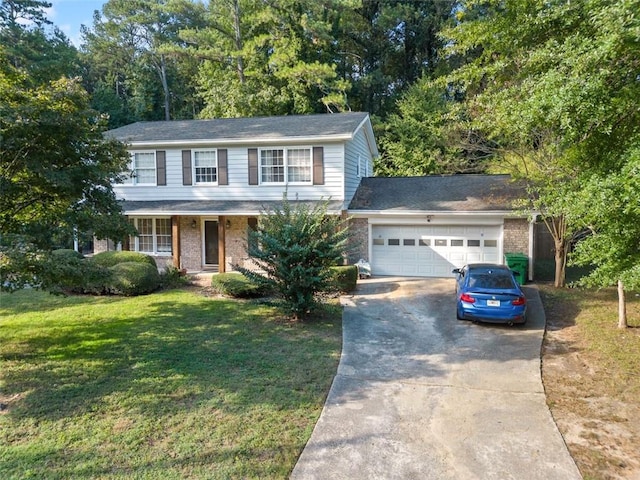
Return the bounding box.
[291,278,581,480]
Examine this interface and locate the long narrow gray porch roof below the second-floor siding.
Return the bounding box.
[121,200,342,215]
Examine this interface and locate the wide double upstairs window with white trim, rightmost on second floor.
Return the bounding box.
[260,148,312,184]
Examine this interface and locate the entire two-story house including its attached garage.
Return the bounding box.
[104,113,535,277]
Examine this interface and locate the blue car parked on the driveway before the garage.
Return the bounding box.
[453,263,527,325]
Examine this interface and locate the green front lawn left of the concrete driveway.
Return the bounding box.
[0,290,341,480]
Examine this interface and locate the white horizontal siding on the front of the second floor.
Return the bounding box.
[114,143,344,201]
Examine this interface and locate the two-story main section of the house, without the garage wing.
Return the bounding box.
[100,113,378,272]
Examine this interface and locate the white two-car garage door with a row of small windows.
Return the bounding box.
[371,225,502,277]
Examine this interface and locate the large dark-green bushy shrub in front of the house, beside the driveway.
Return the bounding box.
[236,196,347,320]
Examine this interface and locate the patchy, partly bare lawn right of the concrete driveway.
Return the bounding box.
[541,286,640,480]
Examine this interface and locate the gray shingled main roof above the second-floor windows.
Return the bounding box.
[105,112,368,143]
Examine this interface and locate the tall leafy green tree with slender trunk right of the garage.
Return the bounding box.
[439,0,640,286]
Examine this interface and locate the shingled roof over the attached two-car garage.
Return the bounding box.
[349,175,526,213]
